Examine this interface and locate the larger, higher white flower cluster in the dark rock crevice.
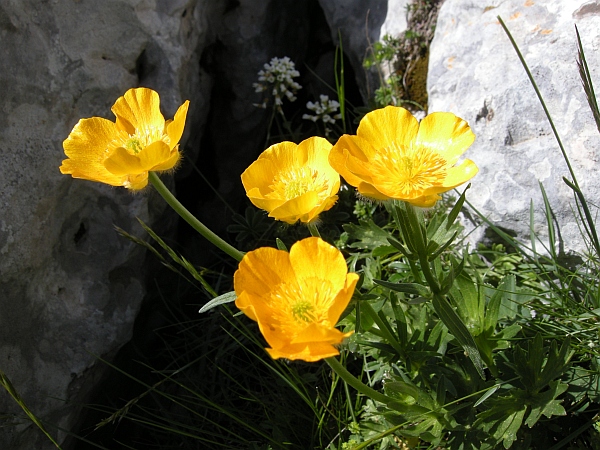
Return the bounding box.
[252,56,302,111]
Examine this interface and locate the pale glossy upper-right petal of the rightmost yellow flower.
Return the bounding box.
[416,112,475,165]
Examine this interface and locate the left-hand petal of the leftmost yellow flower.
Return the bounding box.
[60,117,123,186]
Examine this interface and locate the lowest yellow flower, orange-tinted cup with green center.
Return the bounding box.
[233,237,358,361]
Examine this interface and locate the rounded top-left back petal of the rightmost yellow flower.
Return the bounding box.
[356,106,419,149]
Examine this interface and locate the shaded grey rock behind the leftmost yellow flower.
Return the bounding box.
[0,0,212,450]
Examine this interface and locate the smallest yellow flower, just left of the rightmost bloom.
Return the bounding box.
[242,137,340,224]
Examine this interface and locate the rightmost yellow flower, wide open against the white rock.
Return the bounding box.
[329,106,478,207]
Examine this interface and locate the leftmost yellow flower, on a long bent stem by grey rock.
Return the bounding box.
[60,88,189,190]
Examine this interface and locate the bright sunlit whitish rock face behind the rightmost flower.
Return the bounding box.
[427,0,600,253]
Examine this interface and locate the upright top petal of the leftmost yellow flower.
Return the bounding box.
[111,88,165,135]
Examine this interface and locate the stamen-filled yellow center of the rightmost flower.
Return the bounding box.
[373,142,448,196]
